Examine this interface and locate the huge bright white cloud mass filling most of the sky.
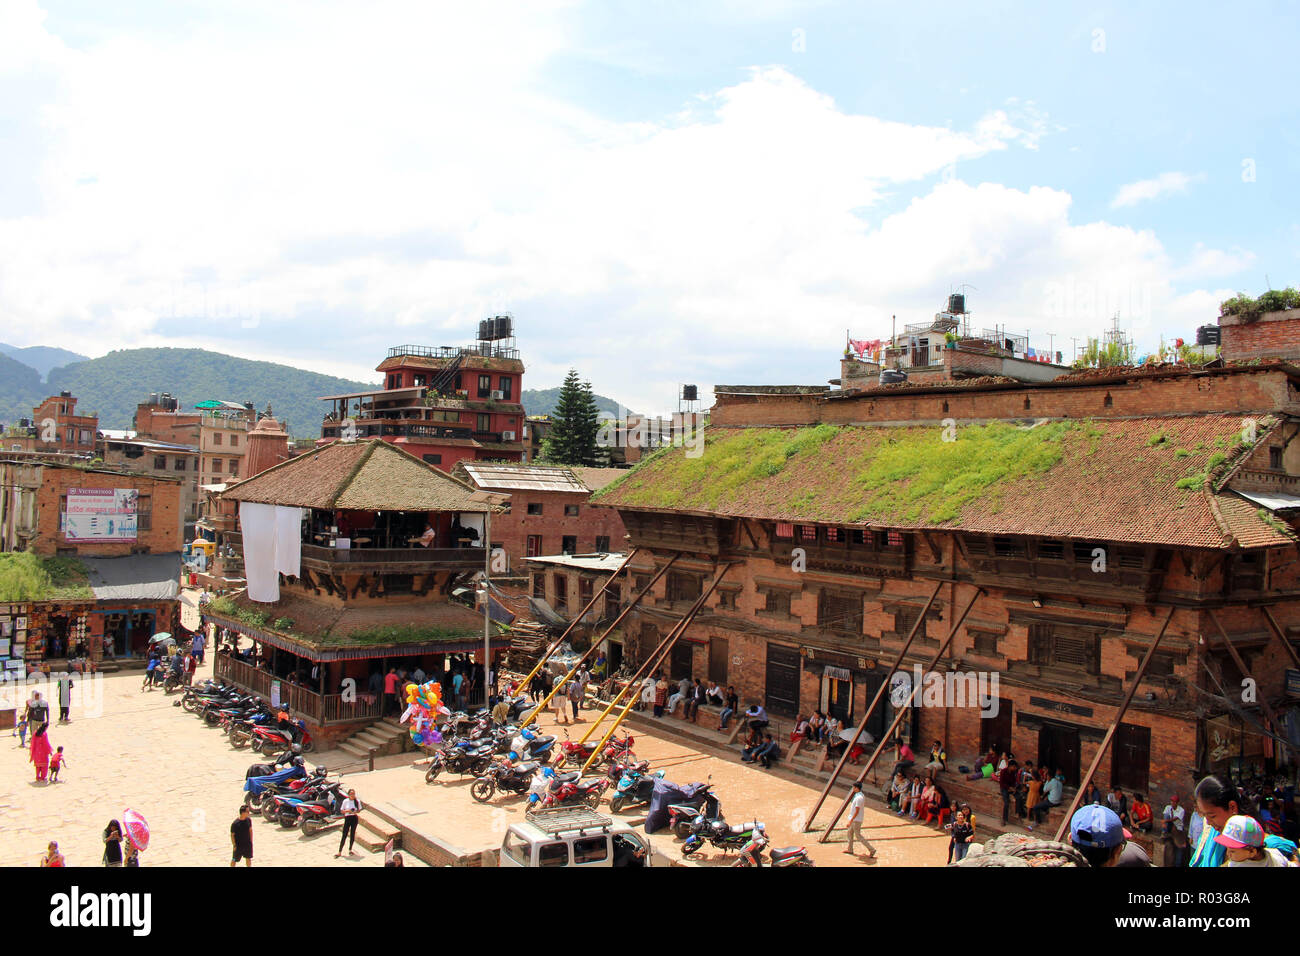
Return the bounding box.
[0,0,1249,411]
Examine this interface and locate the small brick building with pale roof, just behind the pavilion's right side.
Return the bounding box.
[451,462,627,568]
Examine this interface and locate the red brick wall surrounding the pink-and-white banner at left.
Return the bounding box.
[33,467,183,557]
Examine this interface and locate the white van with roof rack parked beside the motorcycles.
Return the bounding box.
[498,806,654,866]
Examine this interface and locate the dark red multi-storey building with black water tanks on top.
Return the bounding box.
[319,316,528,471]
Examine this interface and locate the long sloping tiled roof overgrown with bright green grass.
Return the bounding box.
[592,415,1295,548]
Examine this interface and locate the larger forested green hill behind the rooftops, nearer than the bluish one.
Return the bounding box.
[41,349,374,438]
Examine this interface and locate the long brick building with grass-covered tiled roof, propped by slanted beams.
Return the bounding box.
[593,353,1300,822]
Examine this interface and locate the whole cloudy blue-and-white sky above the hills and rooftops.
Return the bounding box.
[0,0,1300,412]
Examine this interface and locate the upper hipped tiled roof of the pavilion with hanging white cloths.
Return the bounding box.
[222,438,489,511]
